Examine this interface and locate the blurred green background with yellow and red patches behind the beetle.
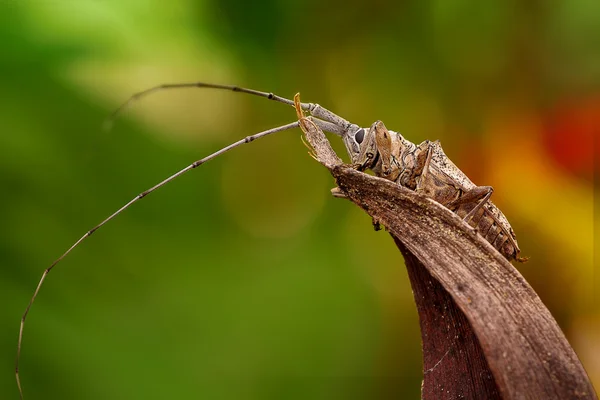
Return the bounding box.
[0,0,600,399]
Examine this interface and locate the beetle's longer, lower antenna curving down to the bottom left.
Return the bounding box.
[15,120,300,400]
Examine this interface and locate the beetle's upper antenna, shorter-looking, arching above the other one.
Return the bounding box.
[104,82,302,130]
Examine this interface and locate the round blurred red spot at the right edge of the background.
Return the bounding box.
[544,97,600,179]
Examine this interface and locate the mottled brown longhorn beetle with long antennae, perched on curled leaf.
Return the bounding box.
[15,82,525,399]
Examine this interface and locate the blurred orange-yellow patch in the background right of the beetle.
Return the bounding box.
[486,110,595,298]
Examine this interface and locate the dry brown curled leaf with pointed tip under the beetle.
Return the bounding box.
[299,96,597,400]
